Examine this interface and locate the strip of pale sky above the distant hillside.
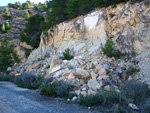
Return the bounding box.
[0,0,46,6]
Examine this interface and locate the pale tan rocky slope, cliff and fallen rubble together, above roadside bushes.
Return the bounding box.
[11,0,150,95]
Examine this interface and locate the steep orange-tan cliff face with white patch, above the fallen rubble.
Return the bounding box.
[40,1,150,53]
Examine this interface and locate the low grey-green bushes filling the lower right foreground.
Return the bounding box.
[79,81,150,113]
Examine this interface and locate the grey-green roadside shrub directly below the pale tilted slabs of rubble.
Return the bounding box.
[40,81,70,97]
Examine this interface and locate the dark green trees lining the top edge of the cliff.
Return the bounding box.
[41,0,133,31]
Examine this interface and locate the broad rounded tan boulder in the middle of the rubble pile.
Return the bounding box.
[73,68,90,79]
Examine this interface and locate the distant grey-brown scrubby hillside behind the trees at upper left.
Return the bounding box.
[0,7,38,39]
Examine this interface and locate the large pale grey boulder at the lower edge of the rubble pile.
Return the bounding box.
[87,79,101,91]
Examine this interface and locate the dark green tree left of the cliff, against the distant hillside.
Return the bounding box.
[20,14,44,48]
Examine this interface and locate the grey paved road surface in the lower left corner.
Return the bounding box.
[0,82,97,113]
